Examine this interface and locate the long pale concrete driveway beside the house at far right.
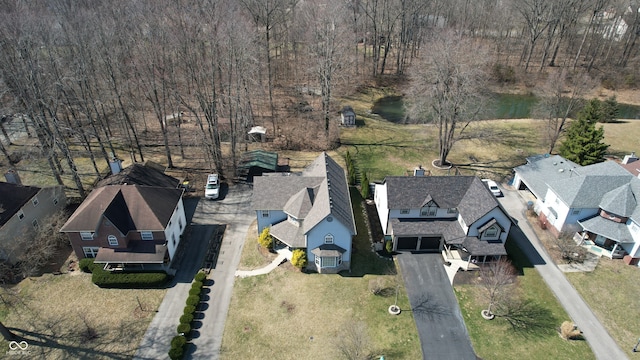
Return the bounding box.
[499,189,628,360]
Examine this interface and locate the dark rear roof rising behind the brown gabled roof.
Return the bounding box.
[96,163,180,189]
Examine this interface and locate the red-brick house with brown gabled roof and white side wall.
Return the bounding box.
[60,185,187,271]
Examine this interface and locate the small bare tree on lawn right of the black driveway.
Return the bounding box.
[478,259,516,319]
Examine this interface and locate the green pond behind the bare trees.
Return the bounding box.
[371,93,640,123]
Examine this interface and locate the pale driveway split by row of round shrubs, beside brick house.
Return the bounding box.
[134,185,255,359]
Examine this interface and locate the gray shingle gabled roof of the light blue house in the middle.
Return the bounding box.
[253,152,356,234]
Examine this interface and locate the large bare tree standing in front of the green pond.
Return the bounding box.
[408,32,487,166]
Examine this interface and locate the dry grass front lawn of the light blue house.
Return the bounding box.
[221,188,422,359]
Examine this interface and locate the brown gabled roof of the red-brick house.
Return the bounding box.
[60,185,182,235]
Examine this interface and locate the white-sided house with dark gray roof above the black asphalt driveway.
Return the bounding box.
[374,176,511,269]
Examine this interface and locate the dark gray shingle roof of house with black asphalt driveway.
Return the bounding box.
[384,176,498,224]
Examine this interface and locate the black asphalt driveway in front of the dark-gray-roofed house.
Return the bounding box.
[397,253,476,360]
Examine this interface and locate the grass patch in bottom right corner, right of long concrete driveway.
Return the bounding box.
[566,257,640,357]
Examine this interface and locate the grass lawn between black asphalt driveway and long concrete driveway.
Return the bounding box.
[455,238,594,360]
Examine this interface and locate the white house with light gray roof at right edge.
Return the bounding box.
[514,155,640,263]
